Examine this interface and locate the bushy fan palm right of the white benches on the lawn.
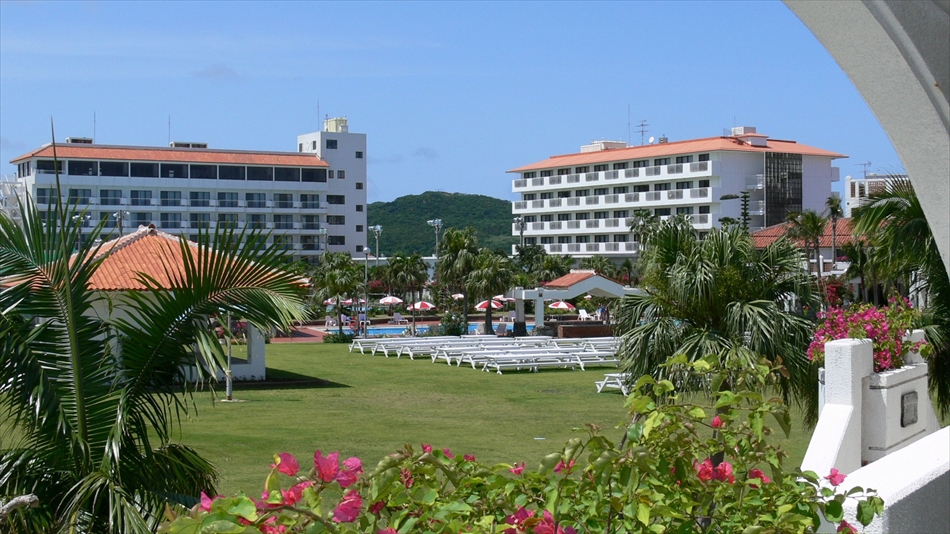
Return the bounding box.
[618,219,817,416]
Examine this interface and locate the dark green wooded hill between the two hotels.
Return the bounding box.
[366,191,517,256]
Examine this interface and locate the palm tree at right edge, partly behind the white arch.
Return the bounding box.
[852,178,950,414]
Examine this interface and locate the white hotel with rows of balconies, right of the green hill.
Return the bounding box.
[509,126,846,258]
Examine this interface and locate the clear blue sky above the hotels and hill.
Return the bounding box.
[0,0,901,201]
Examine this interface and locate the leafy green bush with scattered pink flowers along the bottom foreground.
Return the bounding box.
[160,358,883,534]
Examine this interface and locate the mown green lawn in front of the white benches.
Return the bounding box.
[175,343,810,493]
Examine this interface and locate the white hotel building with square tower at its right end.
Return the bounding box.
[5,118,367,261]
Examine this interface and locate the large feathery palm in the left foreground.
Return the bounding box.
[0,184,305,533]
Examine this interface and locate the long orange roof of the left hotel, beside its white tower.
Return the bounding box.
[10,144,330,167]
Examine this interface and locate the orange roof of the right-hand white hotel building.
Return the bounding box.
[508,134,847,172]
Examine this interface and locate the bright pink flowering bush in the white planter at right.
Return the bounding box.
[808,296,923,373]
